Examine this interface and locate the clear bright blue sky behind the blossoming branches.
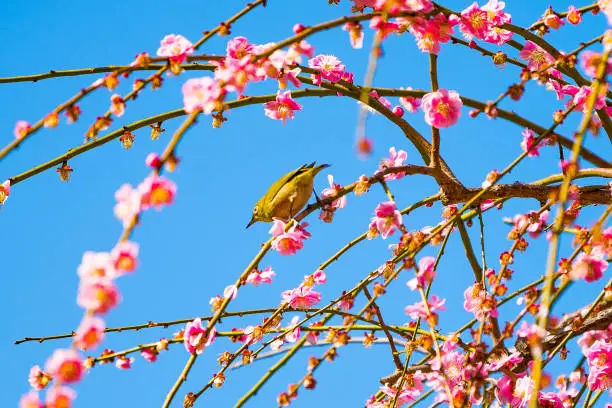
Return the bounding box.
[0,0,612,408]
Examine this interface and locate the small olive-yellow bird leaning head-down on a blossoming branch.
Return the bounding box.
[246,162,329,228]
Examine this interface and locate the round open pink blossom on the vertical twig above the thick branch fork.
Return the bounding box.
[421,89,463,129]
